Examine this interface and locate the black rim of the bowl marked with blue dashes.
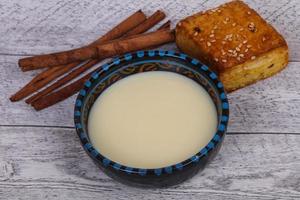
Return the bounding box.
[74,50,229,176]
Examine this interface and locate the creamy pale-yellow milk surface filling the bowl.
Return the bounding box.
[88,72,217,169]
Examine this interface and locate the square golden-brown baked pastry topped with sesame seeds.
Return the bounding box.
[176,1,288,92]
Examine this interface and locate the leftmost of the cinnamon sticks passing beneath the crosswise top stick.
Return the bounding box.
[10,10,146,101]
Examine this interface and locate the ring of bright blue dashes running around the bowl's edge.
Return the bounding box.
[74,50,229,176]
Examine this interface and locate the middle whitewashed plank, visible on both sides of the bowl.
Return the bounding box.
[0,56,300,133]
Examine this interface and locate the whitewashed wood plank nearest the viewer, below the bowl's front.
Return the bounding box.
[0,127,300,200]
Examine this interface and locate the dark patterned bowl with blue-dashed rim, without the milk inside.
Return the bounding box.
[74,50,229,187]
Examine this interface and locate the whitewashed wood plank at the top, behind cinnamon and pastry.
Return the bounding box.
[0,0,300,61]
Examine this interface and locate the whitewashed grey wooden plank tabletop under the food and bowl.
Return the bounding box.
[0,0,300,200]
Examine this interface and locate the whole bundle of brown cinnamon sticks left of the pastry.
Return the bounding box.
[10,10,175,110]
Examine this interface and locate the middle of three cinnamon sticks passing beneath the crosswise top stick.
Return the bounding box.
[25,10,166,104]
